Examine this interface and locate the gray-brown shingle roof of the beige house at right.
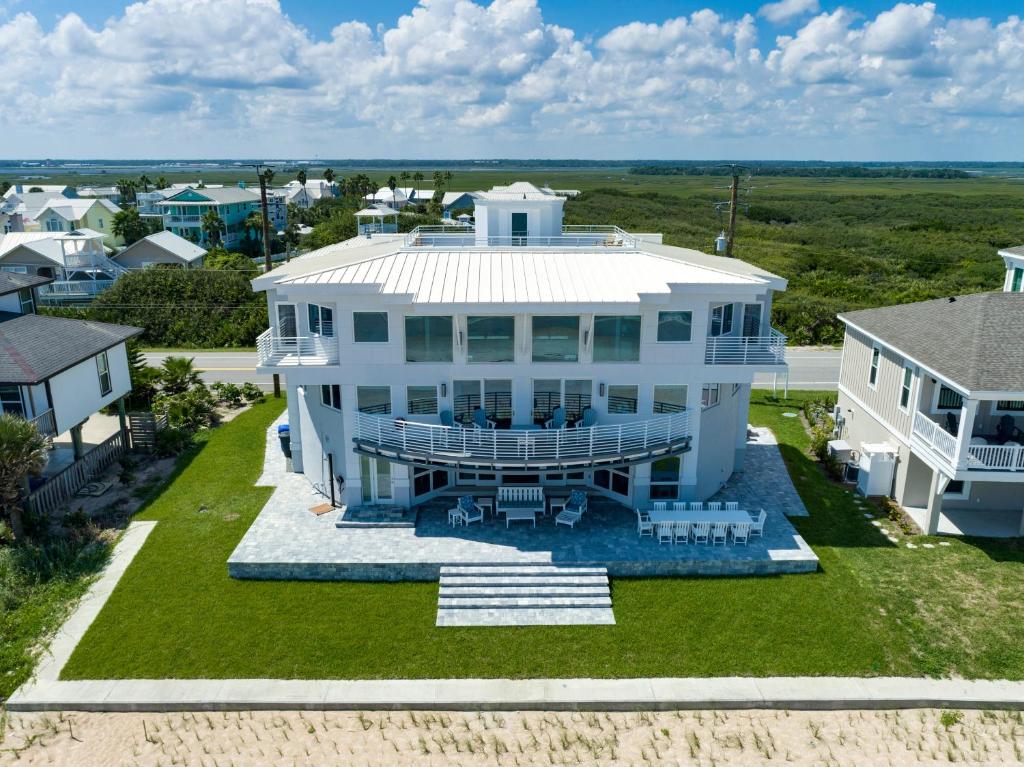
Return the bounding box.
[839,292,1024,392]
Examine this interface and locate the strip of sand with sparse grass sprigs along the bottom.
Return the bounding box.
[0,710,1024,767]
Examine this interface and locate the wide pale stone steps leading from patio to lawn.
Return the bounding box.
[437,564,615,626]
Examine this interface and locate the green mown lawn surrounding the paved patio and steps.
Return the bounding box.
[62,392,1024,679]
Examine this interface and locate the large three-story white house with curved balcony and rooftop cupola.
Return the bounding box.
[253,184,786,507]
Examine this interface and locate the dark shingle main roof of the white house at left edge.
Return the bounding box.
[0,314,142,384]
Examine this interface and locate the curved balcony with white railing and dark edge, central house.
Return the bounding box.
[352,413,690,471]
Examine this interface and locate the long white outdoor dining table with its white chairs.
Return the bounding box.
[637,501,768,546]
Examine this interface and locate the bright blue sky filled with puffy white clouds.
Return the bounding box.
[0,0,1024,160]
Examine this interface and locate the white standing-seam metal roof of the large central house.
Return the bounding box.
[280,249,764,303]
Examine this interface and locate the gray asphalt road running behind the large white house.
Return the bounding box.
[145,346,840,389]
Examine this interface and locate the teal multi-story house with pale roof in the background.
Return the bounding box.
[157,186,260,248]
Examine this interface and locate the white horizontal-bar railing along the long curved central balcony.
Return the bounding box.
[354,413,690,464]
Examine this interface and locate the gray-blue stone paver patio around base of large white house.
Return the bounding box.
[228,415,817,581]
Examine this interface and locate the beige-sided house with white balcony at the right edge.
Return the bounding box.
[838,249,1024,536]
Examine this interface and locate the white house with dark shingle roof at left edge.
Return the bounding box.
[0,272,142,442]
